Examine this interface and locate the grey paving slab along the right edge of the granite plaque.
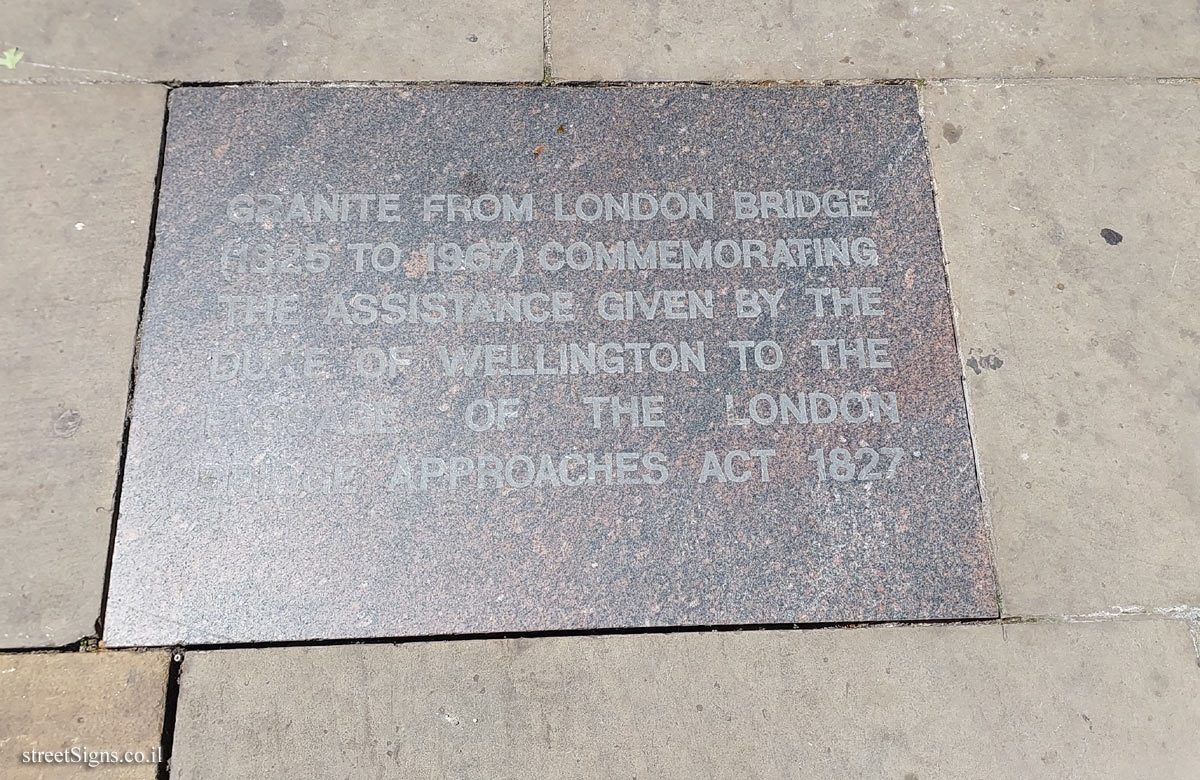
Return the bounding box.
[924,83,1200,614]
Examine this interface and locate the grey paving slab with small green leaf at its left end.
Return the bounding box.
[0,0,542,82]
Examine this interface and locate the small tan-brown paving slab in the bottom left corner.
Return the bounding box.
[0,652,169,780]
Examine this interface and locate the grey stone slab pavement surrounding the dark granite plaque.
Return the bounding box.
[0,0,1200,780]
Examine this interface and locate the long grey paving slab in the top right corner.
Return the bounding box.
[551,0,1200,80]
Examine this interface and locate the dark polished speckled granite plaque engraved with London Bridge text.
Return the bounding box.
[104,86,996,646]
